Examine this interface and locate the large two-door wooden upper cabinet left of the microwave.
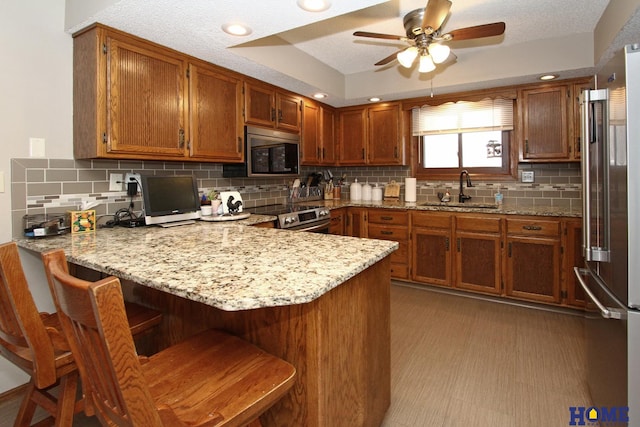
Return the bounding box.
[73,24,243,161]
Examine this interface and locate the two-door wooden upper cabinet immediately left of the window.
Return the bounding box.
[338,103,405,165]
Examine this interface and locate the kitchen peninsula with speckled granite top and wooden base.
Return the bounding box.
[18,222,398,426]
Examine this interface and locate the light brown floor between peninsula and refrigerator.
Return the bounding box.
[0,283,590,427]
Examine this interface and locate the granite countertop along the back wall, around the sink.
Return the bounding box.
[305,199,582,218]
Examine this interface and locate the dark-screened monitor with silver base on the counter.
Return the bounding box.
[141,175,200,226]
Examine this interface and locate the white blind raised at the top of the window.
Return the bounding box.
[411,98,513,136]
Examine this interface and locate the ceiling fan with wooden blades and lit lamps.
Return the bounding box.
[353,0,505,73]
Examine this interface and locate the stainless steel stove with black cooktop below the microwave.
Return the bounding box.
[247,205,331,234]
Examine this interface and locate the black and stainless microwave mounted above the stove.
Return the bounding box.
[222,126,300,178]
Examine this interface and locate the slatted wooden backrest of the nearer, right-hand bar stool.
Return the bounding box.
[42,250,162,426]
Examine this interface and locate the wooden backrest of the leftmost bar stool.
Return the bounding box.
[0,242,58,388]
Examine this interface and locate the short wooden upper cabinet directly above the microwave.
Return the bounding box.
[244,80,302,133]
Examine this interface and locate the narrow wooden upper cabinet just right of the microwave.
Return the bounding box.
[301,100,336,166]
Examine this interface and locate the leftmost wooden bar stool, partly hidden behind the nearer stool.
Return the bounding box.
[0,242,162,427]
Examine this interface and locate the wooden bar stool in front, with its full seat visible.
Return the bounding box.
[43,250,295,427]
